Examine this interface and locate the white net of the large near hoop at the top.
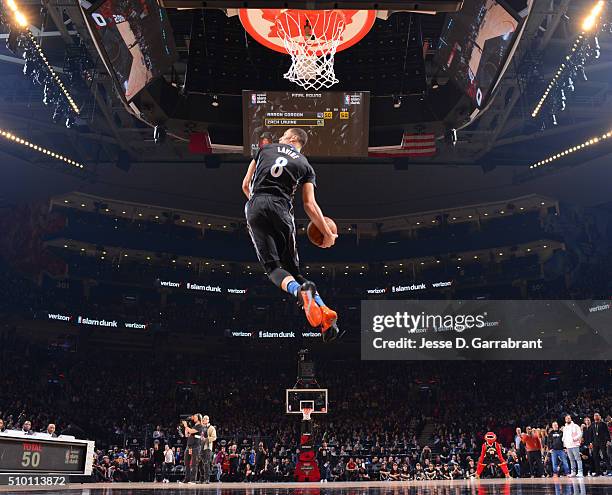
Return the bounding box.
[276,10,346,91]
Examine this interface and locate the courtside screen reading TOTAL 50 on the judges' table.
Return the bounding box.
[0,435,87,474]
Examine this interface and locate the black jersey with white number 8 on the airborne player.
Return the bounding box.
[251,143,316,202]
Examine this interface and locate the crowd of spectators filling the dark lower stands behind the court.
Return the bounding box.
[0,330,612,482]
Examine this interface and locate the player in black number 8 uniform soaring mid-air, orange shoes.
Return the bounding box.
[242,128,339,342]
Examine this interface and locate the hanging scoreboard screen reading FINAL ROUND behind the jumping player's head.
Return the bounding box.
[242,91,370,157]
